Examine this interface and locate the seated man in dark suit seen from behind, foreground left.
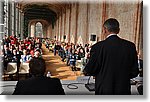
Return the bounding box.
[13,58,65,95]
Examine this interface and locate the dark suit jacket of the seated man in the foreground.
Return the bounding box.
[13,76,65,95]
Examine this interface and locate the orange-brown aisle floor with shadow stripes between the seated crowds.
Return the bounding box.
[42,45,80,80]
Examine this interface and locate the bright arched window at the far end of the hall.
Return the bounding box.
[35,22,43,37]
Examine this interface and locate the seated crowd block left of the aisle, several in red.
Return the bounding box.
[3,35,42,72]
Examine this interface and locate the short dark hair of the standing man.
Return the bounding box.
[103,18,120,34]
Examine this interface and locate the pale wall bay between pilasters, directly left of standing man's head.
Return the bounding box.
[88,3,102,43]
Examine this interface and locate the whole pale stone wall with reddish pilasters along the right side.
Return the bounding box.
[53,0,143,51]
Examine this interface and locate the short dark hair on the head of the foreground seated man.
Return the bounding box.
[29,58,46,76]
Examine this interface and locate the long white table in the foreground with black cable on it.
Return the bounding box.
[0,80,139,95]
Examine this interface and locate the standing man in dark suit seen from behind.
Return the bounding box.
[83,18,139,95]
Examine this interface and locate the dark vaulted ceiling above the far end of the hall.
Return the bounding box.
[15,0,69,36]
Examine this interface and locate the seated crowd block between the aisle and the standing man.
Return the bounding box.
[45,39,91,71]
